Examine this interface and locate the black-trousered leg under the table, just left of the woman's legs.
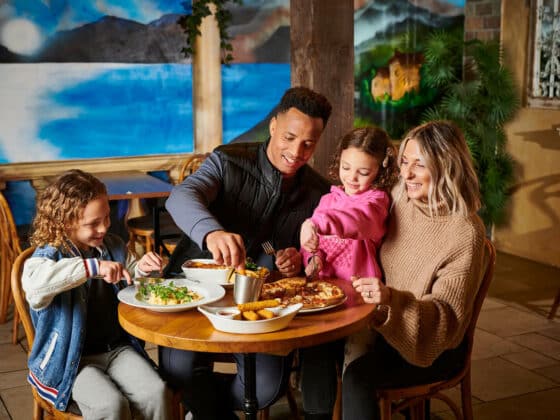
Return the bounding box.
[299,340,344,419]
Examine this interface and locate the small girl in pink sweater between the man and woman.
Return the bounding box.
[301,127,398,280]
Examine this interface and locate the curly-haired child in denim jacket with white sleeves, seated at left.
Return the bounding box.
[22,170,169,420]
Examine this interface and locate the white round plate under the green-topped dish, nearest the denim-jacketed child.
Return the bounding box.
[118,279,226,312]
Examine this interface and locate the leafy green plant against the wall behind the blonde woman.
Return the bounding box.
[422,32,519,226]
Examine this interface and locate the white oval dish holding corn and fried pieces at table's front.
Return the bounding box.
[198,303,302,334]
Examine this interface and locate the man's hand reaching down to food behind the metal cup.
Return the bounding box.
[206,230,246,270]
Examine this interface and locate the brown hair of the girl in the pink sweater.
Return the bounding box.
[329,127,399,192]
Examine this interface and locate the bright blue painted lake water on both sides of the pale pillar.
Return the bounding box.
[29,64,290,159]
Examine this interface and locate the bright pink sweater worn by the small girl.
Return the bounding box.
[301,186,389,280]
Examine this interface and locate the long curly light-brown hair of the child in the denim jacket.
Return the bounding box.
[30,169,107,247]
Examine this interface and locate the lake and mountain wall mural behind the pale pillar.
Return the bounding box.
[0,0,290,164]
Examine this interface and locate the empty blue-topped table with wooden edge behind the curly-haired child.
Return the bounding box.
[96,171,173,200]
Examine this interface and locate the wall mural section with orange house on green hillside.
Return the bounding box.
[354,0,465,139]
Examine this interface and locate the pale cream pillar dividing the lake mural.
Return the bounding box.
[192,0,223,153]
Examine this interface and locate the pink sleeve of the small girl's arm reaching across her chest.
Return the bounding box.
[311,190,389,240]
